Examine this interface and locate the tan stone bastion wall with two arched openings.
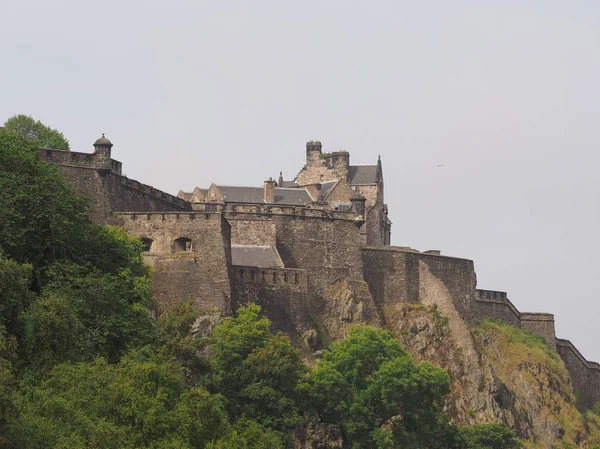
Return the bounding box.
[119,212,232,313]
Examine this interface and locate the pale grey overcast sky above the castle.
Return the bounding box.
[0,0,600,362]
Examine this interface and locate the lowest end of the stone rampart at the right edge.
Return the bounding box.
[556,339,600,409]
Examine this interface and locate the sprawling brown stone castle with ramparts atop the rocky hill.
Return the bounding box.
[39,135,600,408]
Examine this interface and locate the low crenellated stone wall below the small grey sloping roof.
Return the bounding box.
[232,265,312,339]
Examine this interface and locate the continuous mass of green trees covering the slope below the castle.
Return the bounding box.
[0,119,517,449]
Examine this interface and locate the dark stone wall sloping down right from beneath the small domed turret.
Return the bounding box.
[40,149,189,224]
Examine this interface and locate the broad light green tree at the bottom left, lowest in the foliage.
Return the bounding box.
[10,351,228,449]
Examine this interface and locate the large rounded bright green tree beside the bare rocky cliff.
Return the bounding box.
[304,326,450,449]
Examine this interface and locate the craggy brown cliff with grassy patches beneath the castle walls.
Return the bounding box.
[297,288,600,449]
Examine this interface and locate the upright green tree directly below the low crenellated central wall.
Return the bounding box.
[209,304,304,431]
